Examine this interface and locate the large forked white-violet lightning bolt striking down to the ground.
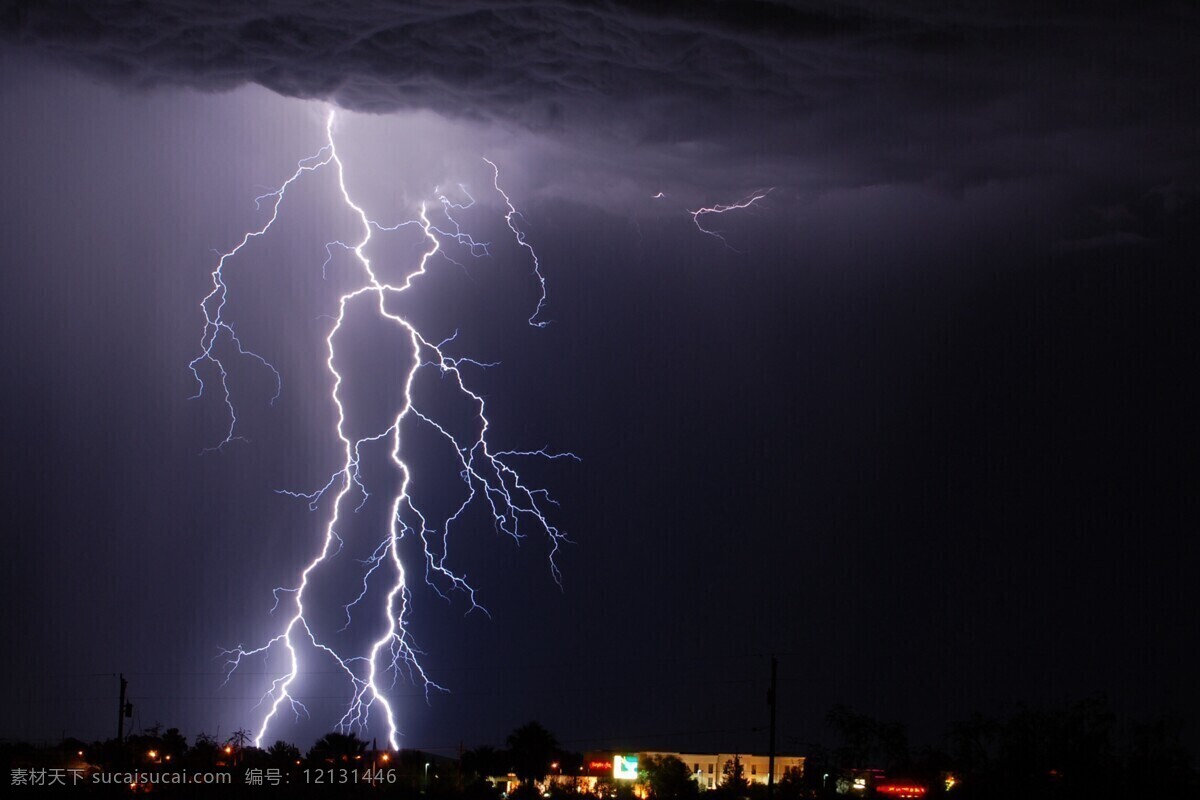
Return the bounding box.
[188,112,577,748]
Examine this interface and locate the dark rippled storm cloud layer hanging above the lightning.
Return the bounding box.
[0,0,1200,190]
